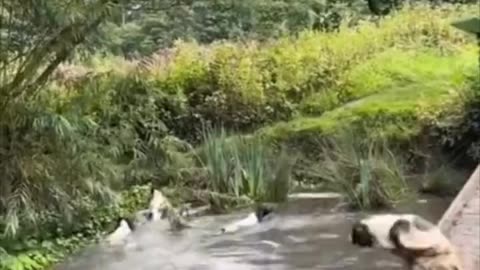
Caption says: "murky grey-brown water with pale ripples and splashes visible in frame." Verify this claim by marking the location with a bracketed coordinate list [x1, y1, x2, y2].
[56, 194, 450, 270]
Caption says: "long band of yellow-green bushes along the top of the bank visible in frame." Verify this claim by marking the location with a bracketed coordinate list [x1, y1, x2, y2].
[70, 6, 471, 142]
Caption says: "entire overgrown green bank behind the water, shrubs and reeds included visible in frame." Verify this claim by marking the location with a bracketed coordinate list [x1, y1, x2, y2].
[0, 6, 480, 269]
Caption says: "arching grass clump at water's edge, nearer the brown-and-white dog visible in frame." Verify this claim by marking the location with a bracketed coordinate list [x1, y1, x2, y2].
[307, 131, 413, 209]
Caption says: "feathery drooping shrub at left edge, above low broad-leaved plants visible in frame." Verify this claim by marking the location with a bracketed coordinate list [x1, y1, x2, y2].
[0, 98, 119, 236]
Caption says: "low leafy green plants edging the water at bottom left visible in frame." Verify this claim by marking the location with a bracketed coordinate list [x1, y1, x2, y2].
[0, 186, 150, 270]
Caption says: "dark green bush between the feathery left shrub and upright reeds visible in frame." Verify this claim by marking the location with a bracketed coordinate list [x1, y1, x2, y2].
[58, 67, 195, 186]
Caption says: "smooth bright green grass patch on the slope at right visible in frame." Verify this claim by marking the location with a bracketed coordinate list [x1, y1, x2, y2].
[260, 46, 477, 141]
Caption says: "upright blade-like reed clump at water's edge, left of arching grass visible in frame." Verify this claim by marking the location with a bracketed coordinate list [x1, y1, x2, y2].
[198, 129, 294, 202]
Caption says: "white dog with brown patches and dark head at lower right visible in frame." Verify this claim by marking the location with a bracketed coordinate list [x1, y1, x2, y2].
[350, 214, 463, 270]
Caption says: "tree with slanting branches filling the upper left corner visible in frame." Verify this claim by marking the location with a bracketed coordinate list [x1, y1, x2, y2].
[0, 0, 116, 110]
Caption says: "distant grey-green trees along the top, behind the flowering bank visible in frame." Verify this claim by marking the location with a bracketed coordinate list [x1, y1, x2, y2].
[92, 0, 363, 57]
